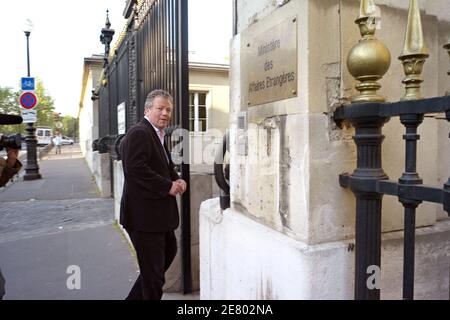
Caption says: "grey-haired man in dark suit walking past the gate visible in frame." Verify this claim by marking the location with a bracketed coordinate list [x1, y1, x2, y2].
[120, 90, 186, 300]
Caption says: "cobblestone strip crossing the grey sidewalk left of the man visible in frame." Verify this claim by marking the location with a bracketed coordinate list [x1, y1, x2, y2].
[0, 199, 114, 243]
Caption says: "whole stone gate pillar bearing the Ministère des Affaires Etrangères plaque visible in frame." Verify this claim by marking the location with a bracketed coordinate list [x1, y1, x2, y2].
[200, 0, 450, 299]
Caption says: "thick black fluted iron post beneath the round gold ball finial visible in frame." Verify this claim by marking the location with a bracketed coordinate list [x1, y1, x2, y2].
[351, 117, 388, 300]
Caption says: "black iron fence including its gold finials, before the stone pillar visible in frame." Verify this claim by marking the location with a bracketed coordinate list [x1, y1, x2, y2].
[333, 0, 450, 299]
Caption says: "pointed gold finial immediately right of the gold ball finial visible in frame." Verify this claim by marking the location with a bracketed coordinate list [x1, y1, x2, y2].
[399, 0, 430, 100]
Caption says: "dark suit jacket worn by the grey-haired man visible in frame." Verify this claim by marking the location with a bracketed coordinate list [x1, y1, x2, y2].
[120, 119, 180, 232]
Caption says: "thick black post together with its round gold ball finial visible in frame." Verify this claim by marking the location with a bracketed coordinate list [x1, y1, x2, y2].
[347, 0, 391, 300]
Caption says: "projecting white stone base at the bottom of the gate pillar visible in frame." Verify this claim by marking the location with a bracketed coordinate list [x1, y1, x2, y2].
[200, 199, 450, 300]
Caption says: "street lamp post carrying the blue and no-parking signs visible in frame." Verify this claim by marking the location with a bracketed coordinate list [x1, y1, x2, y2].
[23, 19, 42, 180]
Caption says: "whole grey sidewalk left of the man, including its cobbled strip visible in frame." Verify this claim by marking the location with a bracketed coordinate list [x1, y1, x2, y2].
[0, 145, 198, 300]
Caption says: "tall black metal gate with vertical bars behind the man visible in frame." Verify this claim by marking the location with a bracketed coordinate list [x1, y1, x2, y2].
[96, 0, 192, 293]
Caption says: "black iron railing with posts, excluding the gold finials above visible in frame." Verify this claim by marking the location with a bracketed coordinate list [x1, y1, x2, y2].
[334, 96, 450, 299]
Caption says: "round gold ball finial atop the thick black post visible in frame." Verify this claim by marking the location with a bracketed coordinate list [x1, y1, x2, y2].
[347, 0, 391, 103]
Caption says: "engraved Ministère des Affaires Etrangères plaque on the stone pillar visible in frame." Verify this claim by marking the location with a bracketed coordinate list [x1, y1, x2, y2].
[241, 17, 298, 107]
